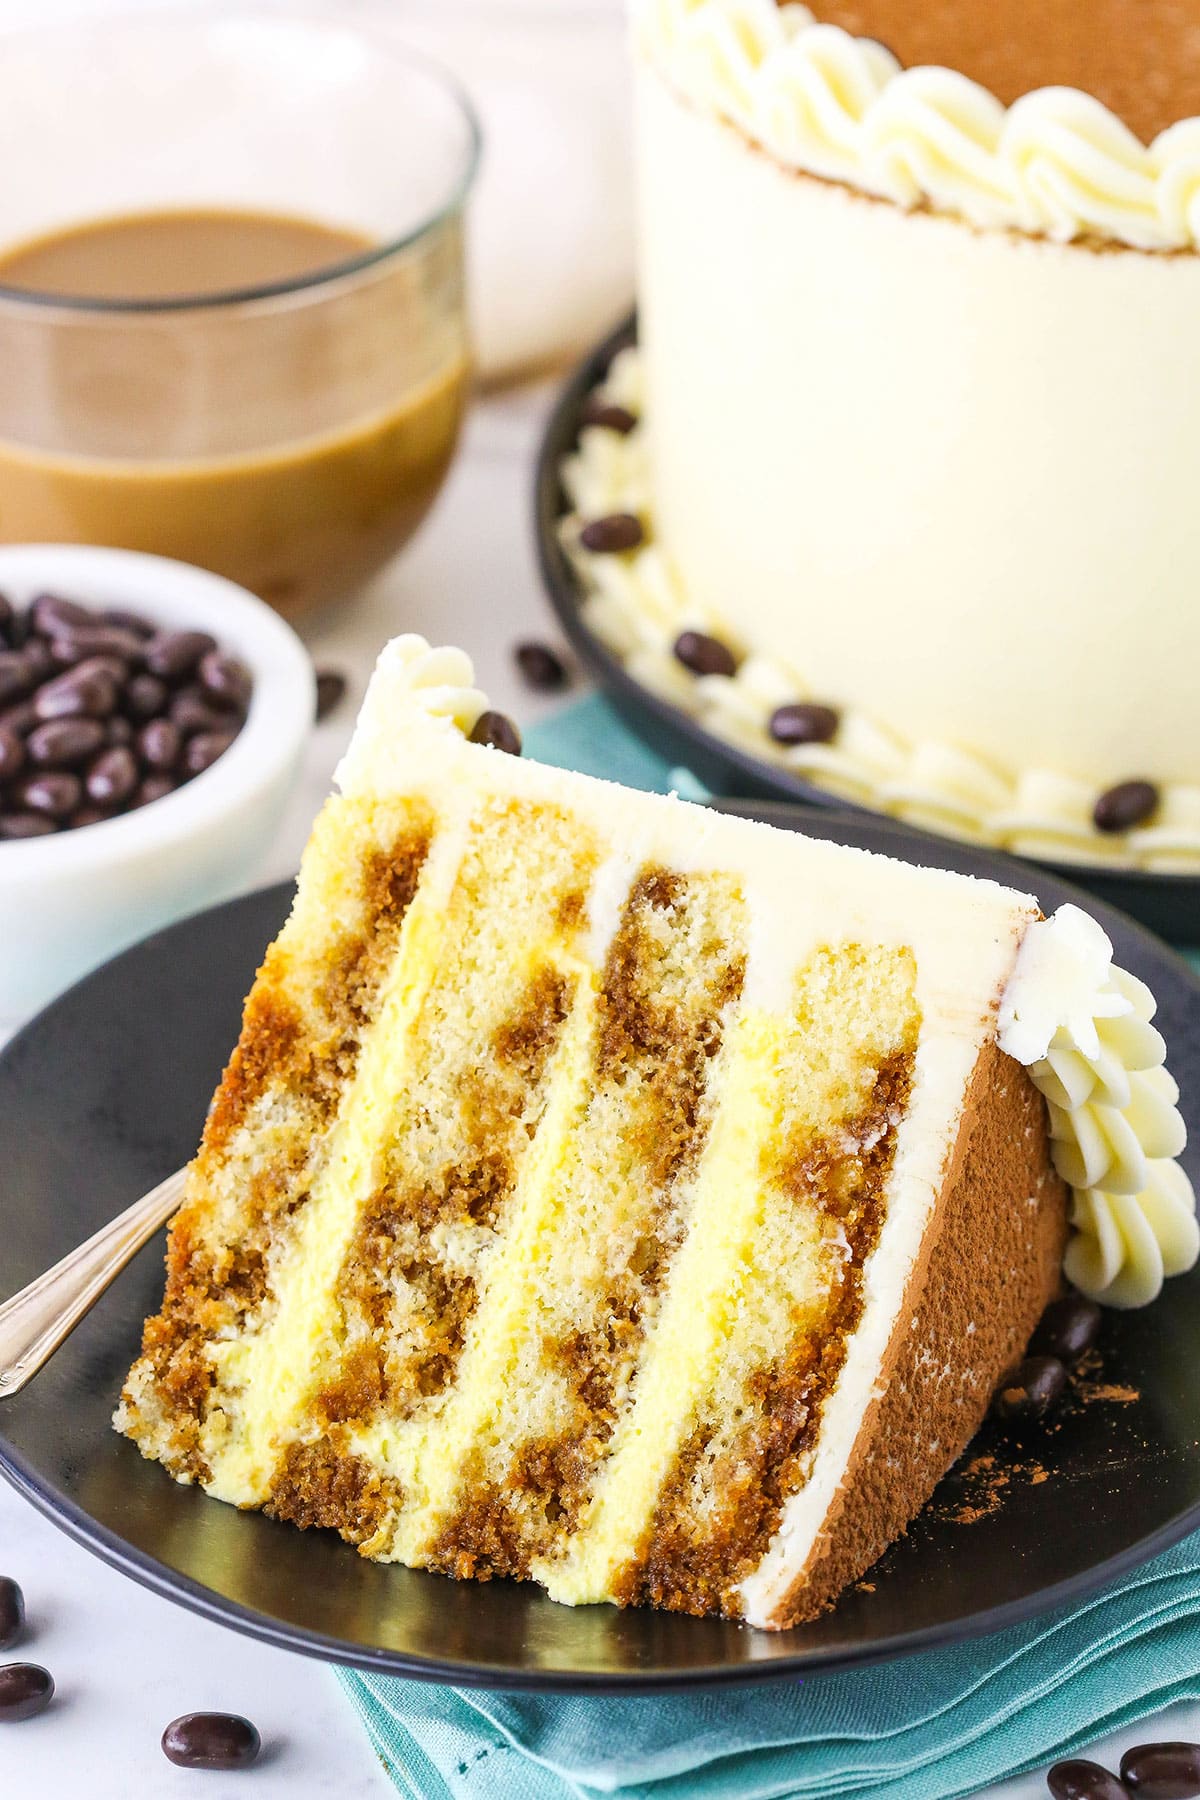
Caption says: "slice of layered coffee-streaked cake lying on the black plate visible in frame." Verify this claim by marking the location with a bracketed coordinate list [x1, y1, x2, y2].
[117, 637, 1195, 1625]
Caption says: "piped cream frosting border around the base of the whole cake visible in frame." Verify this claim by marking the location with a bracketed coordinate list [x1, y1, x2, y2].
[560, 347, 1200, 875]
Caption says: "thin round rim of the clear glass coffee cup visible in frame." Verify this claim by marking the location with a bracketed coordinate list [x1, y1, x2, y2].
[0, 4, 484, 317]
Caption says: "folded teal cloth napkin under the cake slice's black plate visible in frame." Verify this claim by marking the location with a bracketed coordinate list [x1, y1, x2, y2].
[338, 697, 1200, 1800]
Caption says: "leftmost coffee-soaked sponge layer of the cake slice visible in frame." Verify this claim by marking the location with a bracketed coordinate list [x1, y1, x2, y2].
[122, 799, 432, 1481]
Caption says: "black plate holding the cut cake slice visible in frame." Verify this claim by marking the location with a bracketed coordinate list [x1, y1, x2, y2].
[0, 824, 1200, 1690]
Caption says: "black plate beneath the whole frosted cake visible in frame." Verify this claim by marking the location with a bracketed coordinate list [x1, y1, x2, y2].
[534, 319, 1200, 943]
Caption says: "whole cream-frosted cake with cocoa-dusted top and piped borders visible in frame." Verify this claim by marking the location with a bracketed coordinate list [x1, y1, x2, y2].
[567, 0, 1200, 871]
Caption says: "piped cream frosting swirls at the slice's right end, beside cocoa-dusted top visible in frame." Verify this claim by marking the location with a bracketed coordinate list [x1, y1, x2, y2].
[997, 905, 1200, 1307]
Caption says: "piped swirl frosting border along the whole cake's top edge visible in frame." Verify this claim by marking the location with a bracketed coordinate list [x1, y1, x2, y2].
[631, 0, 1200, 250]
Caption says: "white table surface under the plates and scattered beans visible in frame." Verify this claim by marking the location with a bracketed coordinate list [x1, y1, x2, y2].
[0, 389, 1200, 1800]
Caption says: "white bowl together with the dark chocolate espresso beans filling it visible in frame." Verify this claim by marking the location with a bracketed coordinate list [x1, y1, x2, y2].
[0, 544, 315, 1026]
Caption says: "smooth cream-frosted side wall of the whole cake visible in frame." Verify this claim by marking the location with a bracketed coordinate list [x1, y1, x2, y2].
[639, 70, 1200, 799]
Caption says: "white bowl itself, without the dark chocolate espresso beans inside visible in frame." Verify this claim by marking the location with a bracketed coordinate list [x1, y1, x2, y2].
[0, 544, 315, 1026]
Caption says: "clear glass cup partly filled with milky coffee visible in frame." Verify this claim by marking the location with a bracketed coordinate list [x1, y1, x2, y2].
[0, 5, 479, 614]
